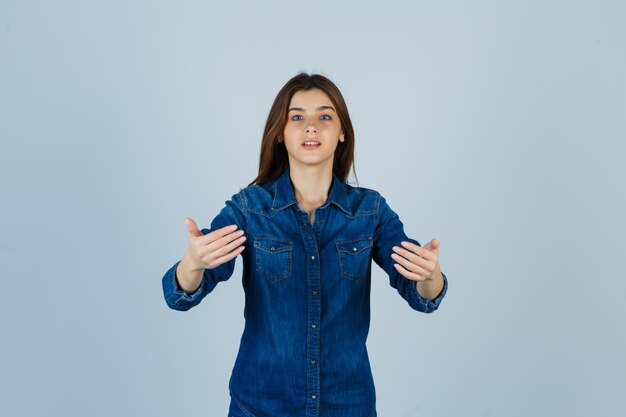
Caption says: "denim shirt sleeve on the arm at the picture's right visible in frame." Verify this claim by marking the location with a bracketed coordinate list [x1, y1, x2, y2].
[372, 195, 448, 313]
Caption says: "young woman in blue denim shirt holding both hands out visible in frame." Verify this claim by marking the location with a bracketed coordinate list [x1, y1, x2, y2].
[162, 73, 448, 417]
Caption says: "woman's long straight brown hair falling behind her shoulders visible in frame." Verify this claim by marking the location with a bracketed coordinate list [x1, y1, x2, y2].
[248, 72, 358, 185]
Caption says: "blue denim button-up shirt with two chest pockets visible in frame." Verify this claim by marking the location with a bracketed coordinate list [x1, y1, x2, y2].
[162, 169, 448, 417]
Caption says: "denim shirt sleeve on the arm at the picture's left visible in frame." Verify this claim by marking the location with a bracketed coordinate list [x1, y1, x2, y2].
[161, 190, 248, 311]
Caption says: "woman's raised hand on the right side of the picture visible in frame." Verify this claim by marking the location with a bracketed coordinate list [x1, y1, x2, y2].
[391, 239, 440, 281]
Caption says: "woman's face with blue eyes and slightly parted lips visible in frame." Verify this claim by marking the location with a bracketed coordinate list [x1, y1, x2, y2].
[283, 88, 344, 170]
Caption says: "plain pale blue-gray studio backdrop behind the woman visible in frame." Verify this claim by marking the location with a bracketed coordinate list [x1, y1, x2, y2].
[0, 0, 626, 417]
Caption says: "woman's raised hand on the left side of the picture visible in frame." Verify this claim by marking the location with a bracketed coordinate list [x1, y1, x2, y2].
[185, 217, 246, 271]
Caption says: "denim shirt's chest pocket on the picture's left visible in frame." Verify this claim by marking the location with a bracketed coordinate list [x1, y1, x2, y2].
[254, 236, 293, 282]
